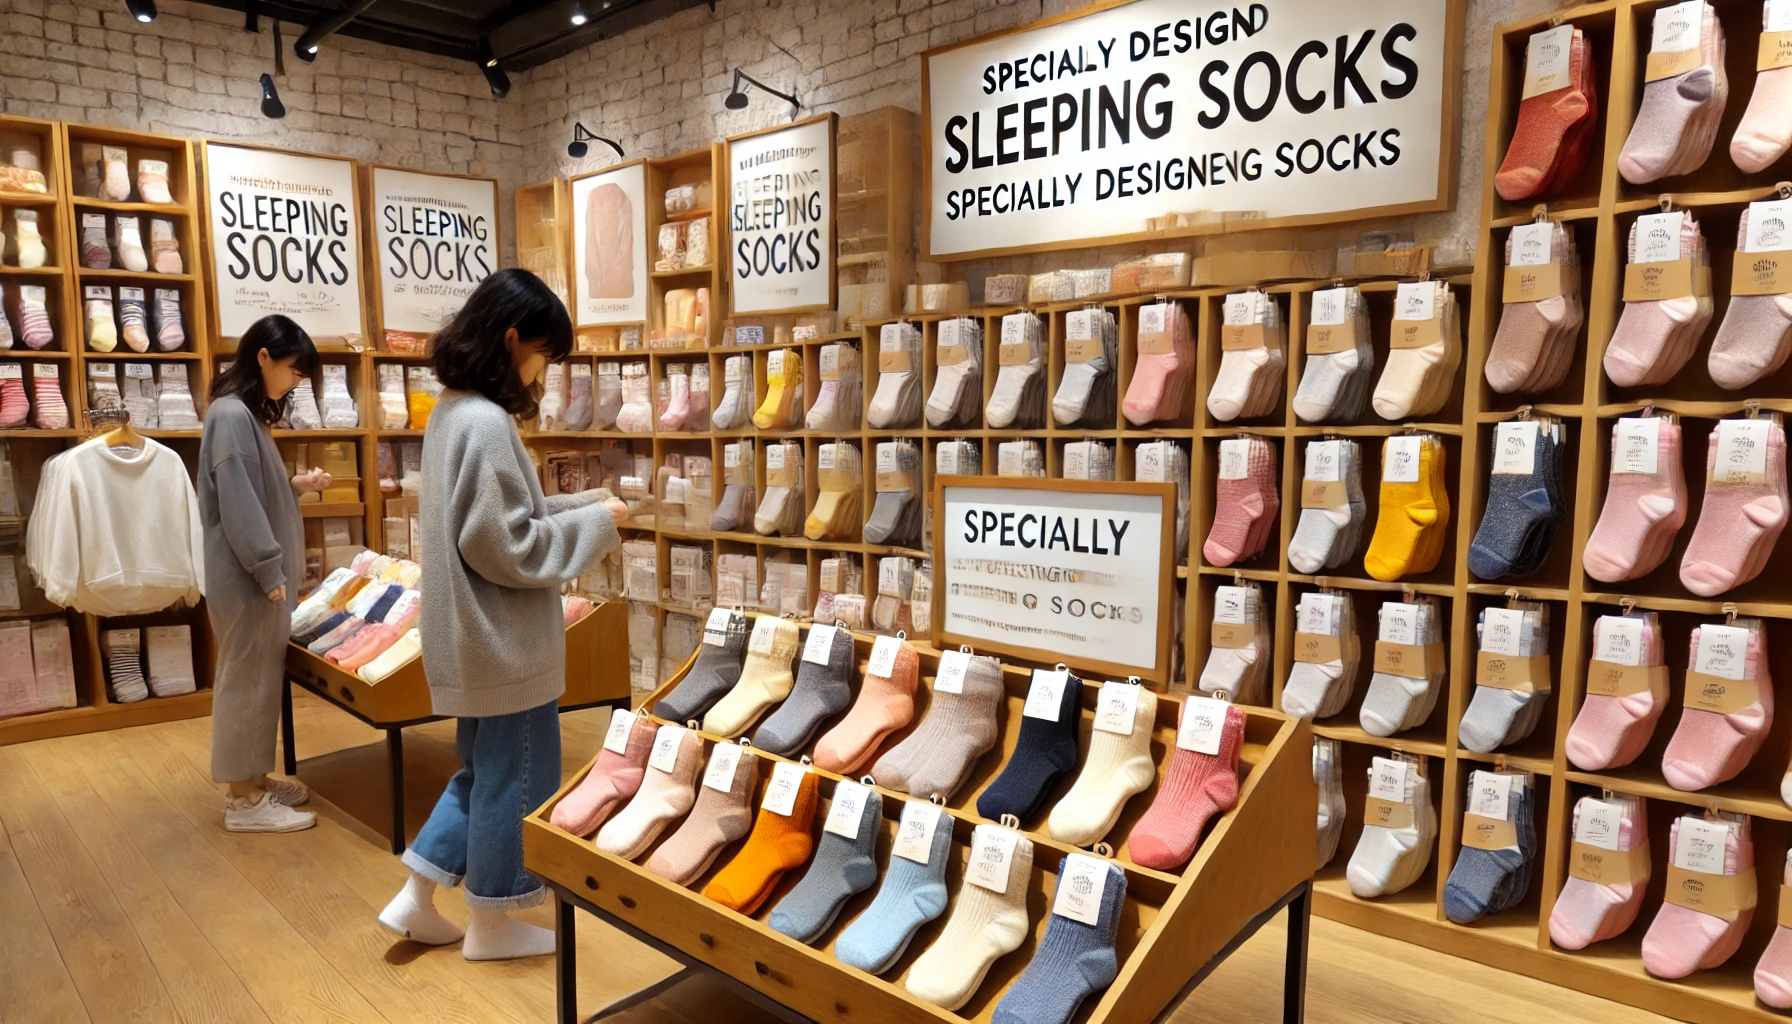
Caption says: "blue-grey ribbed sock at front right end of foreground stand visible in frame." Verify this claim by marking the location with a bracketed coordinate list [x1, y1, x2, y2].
[989, 863, 1125, 1024]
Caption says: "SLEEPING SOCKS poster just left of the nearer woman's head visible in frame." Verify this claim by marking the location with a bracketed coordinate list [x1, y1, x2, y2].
[367, 165, 500, 351]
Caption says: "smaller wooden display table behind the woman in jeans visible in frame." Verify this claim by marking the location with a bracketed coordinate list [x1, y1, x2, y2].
[280, 601, 629, 854]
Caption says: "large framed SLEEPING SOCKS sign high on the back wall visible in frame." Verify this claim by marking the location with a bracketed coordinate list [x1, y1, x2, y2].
[921, 0, 1462, 258]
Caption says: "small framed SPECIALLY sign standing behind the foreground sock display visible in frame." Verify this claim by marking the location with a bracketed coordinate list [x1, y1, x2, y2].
[934, 477, 1176, 680]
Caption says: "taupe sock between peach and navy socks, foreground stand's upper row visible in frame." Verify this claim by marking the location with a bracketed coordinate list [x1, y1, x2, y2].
[871, 653, 1007, 800]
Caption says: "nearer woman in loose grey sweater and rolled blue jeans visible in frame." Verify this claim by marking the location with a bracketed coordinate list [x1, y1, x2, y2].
[380, 269, 627, 959]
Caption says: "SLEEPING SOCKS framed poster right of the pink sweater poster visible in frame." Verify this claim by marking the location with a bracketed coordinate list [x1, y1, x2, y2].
[728, 113, 839, 314]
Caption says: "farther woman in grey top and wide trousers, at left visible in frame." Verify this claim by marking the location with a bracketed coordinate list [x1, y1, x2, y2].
[199, 316, 330, 832]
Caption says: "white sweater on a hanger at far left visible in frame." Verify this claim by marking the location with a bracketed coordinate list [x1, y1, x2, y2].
[25, 438, 206, 615]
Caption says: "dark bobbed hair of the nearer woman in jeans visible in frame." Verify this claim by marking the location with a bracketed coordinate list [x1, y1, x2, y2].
[432, 267, 572, 418]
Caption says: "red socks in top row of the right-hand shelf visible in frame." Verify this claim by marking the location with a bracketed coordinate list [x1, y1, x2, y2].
[1493, 29, 1598, 203]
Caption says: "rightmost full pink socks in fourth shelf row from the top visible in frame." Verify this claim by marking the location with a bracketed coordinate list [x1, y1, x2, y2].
[1661, 619, 1774, 793]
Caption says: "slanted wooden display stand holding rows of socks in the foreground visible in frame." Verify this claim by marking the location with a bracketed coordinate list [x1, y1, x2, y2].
[523, 635, 1317, 1024]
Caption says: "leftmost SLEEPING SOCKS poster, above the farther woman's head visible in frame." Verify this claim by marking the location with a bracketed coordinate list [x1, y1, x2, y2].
[204, 142, 367, 348]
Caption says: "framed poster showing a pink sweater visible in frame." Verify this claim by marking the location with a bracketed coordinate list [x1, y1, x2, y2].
[572, 160, 647, 326]
